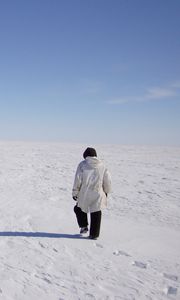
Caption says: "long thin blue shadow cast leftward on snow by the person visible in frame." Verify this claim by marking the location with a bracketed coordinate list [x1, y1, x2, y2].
[0, 231, 85, 239]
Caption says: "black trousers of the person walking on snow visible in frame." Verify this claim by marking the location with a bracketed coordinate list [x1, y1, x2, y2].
[74, 205, 102, 237]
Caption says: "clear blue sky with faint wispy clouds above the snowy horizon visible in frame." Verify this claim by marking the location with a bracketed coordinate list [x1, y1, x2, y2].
[0, 0, 180, 145]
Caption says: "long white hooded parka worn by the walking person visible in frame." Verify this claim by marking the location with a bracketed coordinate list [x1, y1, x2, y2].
[72, 156, 111, 213]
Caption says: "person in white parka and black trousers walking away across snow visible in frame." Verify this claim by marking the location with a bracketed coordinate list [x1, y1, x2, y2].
[72, 147, 111, 239]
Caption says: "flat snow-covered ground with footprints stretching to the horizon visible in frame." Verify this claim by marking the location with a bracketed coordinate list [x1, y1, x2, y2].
[0, 142, 180, 300]
